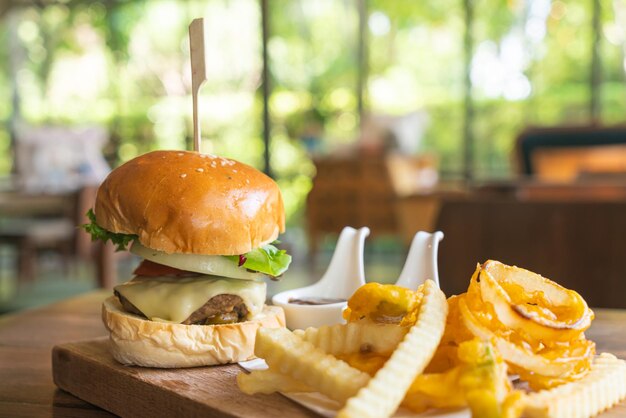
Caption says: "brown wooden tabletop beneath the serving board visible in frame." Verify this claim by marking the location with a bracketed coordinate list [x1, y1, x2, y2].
[0, 291, 626, 417]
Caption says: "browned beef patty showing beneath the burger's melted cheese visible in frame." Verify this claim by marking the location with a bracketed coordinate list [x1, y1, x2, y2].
[114, 291, 248, 325]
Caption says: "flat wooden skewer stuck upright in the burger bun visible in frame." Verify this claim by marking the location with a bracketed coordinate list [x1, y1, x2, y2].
[189, 18, 207, 152]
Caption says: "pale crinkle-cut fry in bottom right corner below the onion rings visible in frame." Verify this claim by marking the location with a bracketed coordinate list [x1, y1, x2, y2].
[524, 353, 626, 418]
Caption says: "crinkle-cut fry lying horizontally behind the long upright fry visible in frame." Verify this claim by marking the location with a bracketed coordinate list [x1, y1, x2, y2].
[294, 322, 409, 356]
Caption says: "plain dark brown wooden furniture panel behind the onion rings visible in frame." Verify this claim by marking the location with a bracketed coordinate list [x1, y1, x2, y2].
[436, 196, 626, 309]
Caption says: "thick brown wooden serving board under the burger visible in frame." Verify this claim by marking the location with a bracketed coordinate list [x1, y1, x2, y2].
[52, 338, 318, 417]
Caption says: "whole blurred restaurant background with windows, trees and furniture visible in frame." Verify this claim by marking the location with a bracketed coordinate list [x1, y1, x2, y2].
[0, 0, 626, 312]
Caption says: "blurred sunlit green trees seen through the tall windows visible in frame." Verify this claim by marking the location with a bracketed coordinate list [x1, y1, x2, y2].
[0, 0, 626, 222]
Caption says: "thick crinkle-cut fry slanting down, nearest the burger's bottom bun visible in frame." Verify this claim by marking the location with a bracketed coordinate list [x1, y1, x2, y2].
[254, 328, 370, 402]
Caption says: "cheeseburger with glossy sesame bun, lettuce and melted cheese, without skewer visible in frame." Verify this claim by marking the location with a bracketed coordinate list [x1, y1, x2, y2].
[84, 151, 291, 368]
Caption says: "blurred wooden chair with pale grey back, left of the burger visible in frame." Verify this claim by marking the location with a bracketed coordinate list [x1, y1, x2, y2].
[0, 125, 115, 287]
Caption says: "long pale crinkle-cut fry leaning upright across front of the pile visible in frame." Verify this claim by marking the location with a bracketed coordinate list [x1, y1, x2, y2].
[337, 280, 448, 418]
